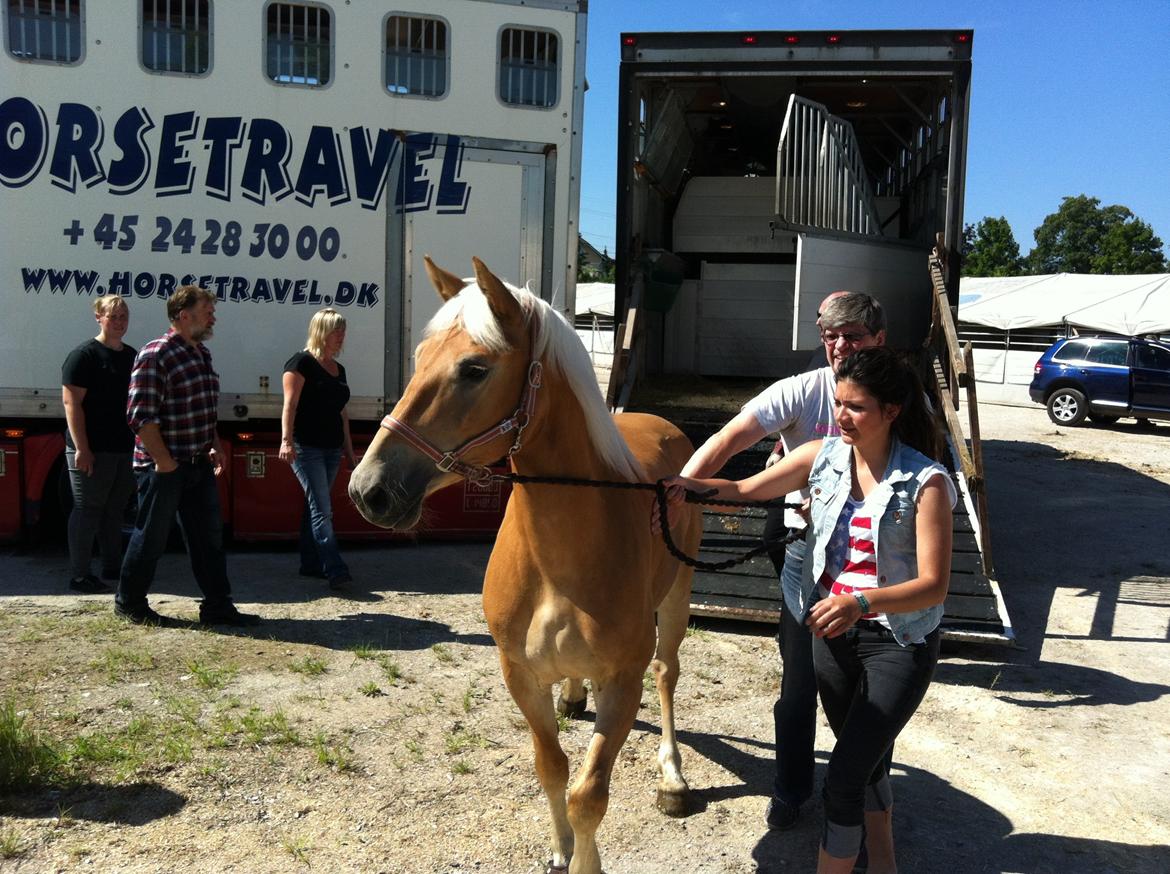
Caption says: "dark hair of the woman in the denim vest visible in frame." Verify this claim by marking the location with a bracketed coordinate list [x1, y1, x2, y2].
[837, 346, 944, 461]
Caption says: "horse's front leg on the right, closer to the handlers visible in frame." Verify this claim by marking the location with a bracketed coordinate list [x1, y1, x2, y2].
[569, 668, 644, 874]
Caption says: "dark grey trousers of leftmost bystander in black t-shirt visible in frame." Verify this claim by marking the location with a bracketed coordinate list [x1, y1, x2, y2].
[66, 447, 135, 579]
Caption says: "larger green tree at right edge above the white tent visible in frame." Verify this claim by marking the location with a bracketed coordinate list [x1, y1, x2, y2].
[1028, 194, 1165, 274]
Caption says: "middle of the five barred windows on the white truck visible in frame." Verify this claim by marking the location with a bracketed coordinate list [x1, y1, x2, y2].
[264, 4, 333, 88]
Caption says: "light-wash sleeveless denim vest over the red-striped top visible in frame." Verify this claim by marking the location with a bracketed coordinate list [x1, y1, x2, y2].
[800, 436, 947, 646]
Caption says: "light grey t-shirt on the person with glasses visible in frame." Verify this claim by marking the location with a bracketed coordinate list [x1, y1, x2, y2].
[743, 366, 841, 528]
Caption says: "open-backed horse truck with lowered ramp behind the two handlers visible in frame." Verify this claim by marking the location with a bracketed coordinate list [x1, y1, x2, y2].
[611, 29, 1010, 638]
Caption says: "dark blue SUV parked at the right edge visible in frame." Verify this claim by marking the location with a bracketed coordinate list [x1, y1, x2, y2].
[1028, 337, 1170, 425]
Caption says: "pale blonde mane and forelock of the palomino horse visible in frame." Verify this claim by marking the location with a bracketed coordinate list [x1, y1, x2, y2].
[424, 278, 646, 482]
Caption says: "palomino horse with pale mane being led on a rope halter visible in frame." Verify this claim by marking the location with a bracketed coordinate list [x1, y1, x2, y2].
[350, 257, 700, 874]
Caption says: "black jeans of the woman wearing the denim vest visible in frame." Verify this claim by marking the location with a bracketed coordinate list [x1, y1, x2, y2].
[812, 621, 938, 842]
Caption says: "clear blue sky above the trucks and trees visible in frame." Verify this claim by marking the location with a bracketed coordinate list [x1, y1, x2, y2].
[580, 0, 1170, 254]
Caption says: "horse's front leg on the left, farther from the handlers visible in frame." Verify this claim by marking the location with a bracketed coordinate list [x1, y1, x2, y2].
[500, 653, 573, 868]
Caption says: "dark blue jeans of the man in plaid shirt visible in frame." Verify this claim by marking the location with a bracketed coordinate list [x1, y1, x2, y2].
[113, 457, 232, 612]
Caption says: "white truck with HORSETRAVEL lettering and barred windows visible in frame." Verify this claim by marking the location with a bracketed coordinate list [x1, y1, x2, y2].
[0, 0, 587, 539]
